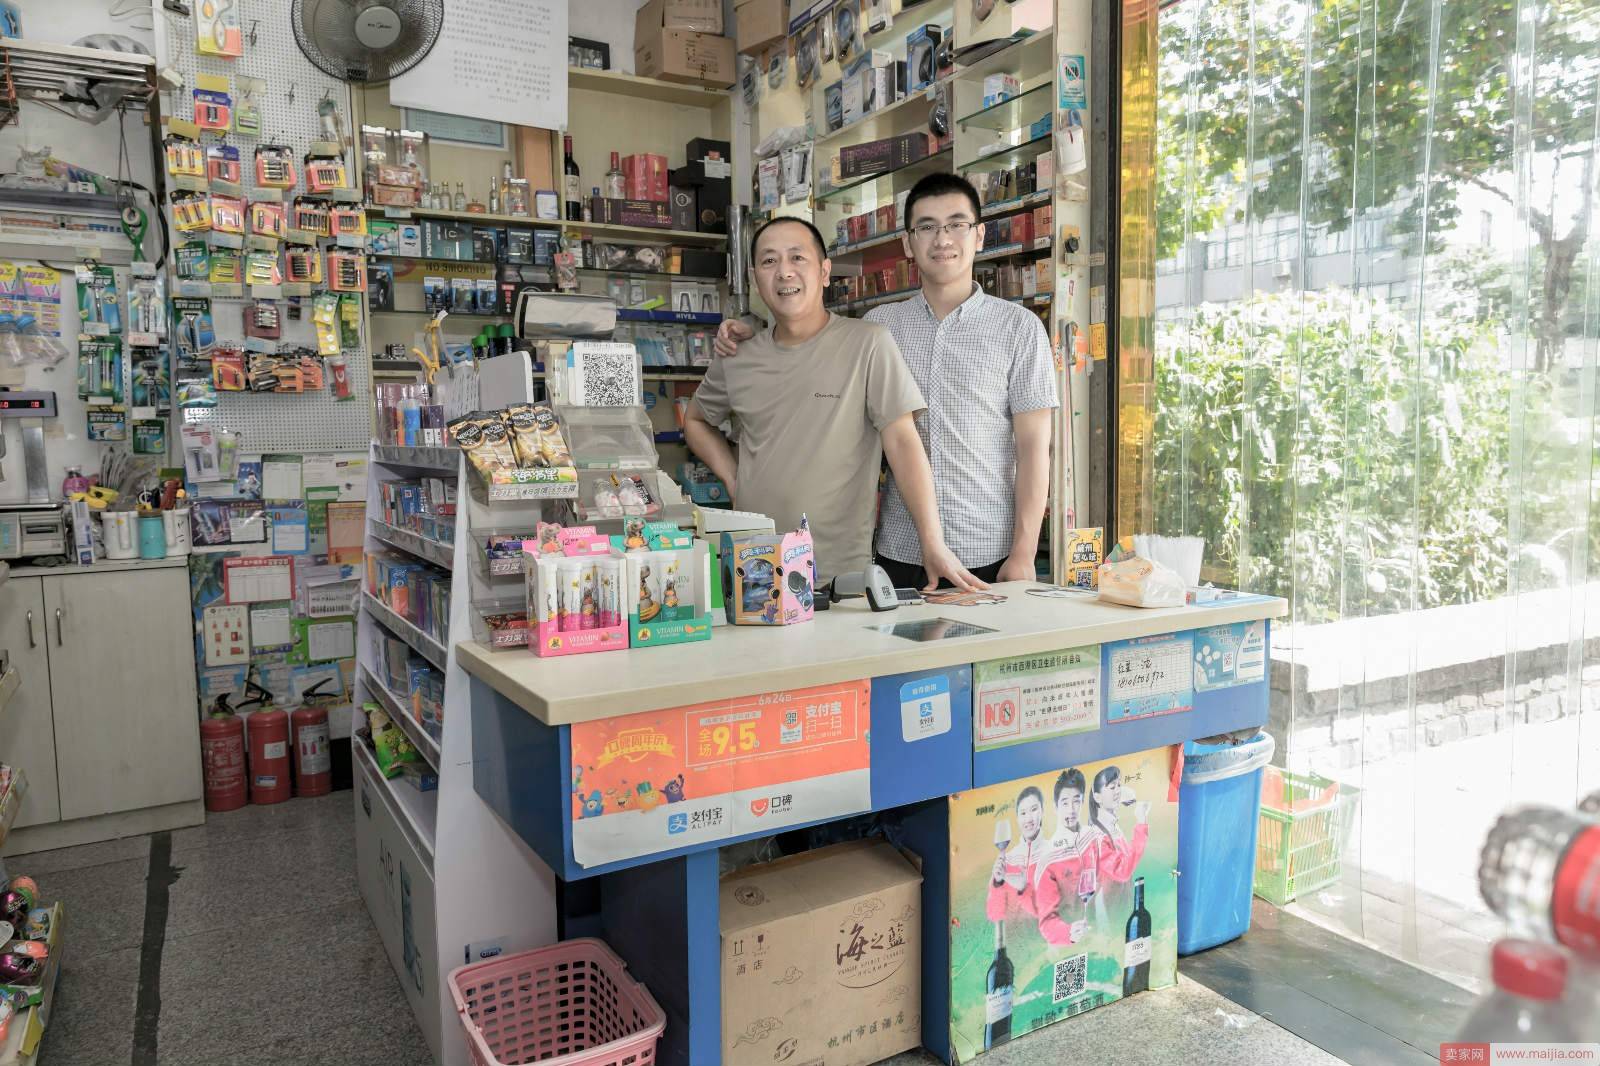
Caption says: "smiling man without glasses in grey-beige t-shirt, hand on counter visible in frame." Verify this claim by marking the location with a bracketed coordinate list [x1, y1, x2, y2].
[683, 218, 974, 589]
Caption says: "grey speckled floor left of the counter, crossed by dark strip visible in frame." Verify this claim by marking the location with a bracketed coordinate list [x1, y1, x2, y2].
[30, 792, 432, 1066]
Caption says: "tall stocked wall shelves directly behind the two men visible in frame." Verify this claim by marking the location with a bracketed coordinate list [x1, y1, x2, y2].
[736, 0, 1106, 575]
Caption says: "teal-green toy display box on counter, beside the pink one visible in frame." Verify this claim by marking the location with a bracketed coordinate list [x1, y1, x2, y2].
[611, 519, 712, 648]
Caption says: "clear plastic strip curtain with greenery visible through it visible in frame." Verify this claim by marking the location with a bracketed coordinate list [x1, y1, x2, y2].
[1118, 0, 1600, 983]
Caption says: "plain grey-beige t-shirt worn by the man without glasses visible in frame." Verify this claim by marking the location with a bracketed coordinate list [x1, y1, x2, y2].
[694, 315, 926, 578]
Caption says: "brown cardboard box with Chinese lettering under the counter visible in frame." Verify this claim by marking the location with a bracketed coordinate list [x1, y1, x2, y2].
[720, 840, 922, 1066]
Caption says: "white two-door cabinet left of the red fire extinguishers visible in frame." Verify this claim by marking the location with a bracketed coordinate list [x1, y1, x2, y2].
[0, 559, 205, 853]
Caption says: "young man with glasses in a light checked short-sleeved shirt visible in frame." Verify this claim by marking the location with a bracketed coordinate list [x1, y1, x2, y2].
[715, 174, 1059, 587]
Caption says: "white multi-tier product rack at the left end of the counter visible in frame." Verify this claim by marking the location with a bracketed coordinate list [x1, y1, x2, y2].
[350, 367, 555, 1066]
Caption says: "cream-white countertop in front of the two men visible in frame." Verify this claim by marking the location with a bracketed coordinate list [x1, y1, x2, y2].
[456, 581, 1288, 725]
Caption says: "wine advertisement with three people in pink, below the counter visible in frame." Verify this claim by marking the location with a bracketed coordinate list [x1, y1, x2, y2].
[950, 747, 1181, 1063]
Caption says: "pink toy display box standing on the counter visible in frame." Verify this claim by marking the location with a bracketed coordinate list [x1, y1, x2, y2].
[523, 525, 627, 656]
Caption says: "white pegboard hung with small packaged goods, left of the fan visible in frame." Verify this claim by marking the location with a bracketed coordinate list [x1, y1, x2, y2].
[154, 0, 371, 453]
